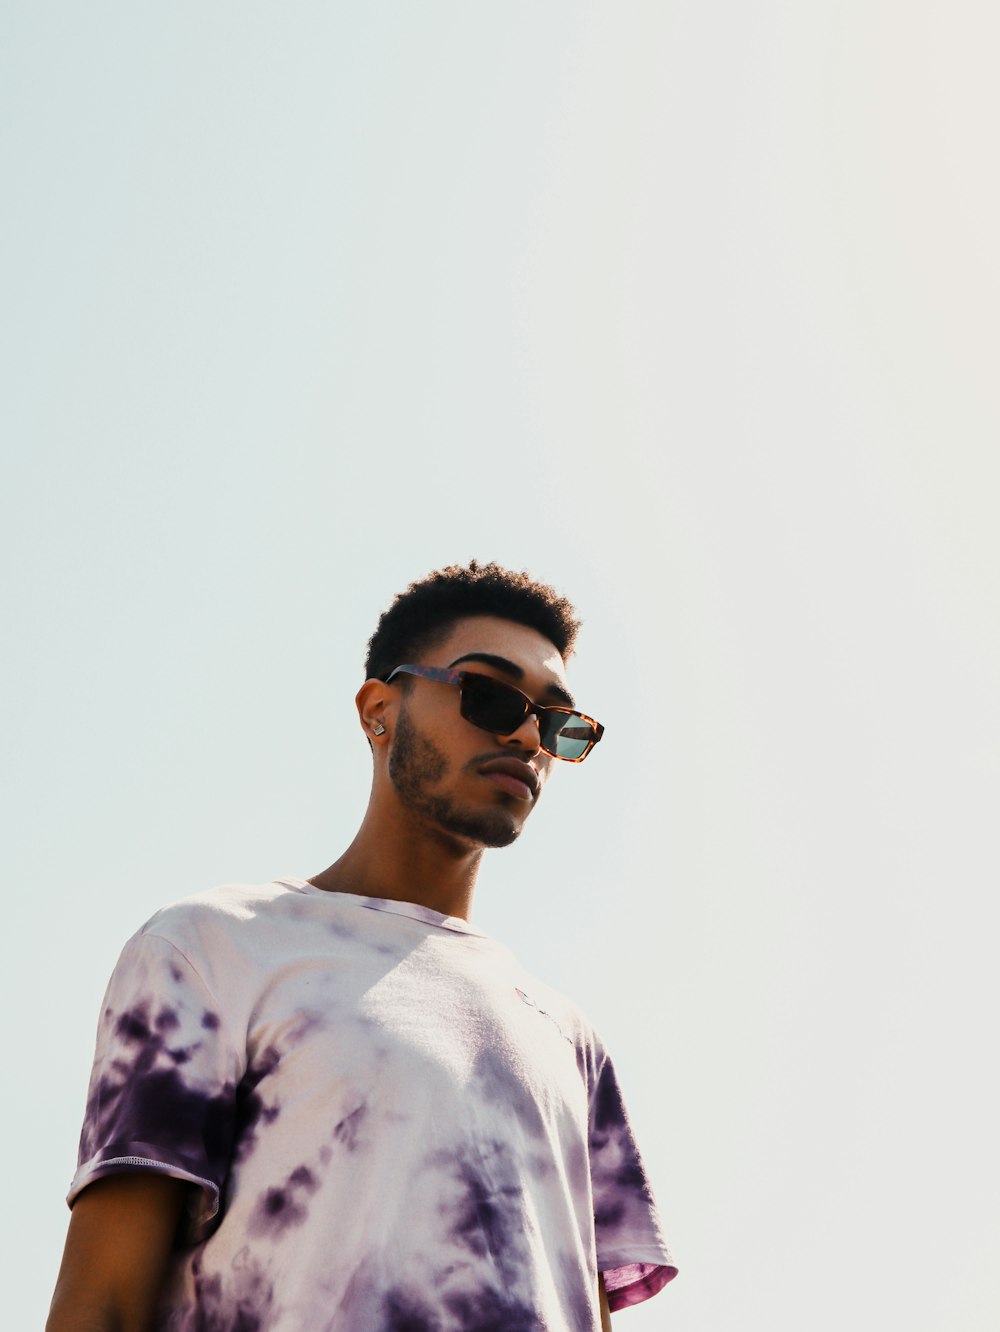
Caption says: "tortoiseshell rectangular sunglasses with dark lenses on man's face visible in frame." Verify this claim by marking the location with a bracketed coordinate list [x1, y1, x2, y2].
[386, 666, 605, 763]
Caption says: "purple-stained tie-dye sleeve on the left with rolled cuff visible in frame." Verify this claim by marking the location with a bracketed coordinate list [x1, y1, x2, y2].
[67, 932, 240, 1239]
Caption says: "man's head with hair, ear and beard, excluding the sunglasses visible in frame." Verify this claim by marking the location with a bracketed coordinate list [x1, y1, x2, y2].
[357, 562, 579, 847]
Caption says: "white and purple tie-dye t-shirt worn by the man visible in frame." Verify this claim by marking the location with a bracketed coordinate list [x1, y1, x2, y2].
[69, 879, 675, 1332]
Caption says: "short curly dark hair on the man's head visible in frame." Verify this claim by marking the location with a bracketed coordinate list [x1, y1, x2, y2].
[365, 559, 581, 679]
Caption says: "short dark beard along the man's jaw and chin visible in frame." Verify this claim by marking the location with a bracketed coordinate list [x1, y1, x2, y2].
[389, 705, 521, 847]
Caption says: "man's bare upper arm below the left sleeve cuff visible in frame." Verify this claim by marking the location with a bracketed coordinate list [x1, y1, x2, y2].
[45, 1171, 190, 1332]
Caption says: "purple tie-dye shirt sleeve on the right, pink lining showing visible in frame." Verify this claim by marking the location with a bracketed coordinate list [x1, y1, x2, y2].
[590, 1055, 676, 1313]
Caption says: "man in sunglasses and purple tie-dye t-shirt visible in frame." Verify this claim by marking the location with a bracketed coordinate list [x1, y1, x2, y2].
[48, 562, 676, 1332]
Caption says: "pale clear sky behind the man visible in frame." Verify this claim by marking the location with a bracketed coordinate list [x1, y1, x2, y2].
[0, 0, 1000, 1332]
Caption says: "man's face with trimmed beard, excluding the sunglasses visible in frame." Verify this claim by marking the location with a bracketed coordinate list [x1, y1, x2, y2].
[389, 615, 570, 846]
